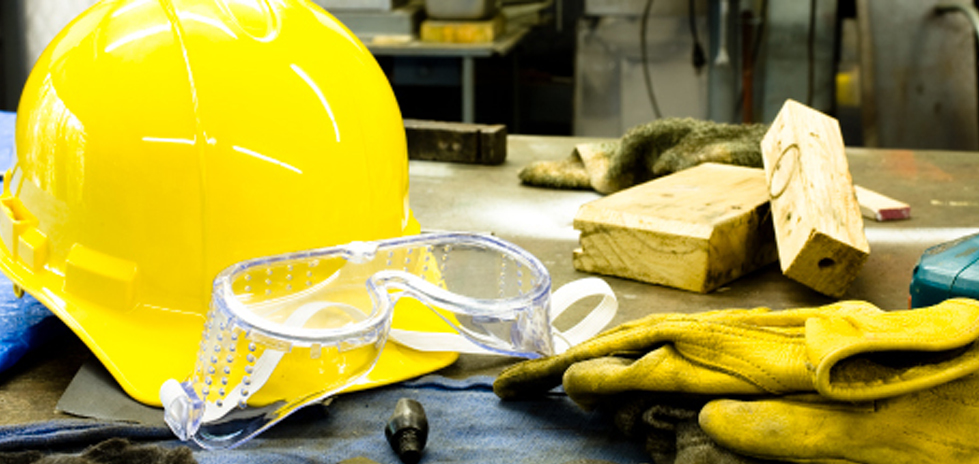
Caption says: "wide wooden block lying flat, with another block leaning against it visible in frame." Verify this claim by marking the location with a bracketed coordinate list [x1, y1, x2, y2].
[574, 163, 776, 293]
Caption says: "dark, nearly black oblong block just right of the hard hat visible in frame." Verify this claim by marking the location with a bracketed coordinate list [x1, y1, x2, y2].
[405, 119, 506, 164]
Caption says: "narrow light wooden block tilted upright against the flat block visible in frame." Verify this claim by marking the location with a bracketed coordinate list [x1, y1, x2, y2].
[761, 100, 870, 297]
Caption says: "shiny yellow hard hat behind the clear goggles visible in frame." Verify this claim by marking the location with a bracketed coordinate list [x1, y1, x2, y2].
[0, 0, 457, 405]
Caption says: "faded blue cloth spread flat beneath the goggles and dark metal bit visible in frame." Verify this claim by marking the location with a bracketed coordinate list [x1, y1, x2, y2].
[0, 375, 650, 464]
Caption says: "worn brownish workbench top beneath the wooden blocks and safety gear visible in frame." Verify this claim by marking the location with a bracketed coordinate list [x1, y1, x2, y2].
[0, 136, 979, 424]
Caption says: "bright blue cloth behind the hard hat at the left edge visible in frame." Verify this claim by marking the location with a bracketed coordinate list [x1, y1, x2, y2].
[0, 111, 67, 373]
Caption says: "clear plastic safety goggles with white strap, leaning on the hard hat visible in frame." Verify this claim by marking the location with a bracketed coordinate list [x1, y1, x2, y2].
[160, 233, 617, 448]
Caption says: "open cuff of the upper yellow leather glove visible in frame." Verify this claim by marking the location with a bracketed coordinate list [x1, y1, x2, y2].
[806, 299, 979, 401]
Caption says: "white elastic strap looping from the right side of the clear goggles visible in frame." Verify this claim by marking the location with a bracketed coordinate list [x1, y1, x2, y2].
[390, 277, 619, 354]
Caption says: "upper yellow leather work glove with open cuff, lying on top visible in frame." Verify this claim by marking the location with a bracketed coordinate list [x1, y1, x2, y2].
[493, 299, 979, 408]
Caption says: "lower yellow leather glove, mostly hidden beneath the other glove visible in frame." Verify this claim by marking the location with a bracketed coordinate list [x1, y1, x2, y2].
[699, 374, 979, 464]
